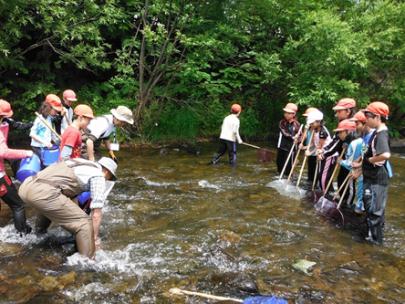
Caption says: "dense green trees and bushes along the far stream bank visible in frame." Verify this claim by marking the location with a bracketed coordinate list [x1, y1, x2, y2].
[0, 0, 405, 140]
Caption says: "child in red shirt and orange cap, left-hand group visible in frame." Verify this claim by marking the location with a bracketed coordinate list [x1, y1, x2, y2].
[59, 105, 94, 160]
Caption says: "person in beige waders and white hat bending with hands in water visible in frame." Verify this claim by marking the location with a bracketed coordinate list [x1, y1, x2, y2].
[18, 157, 117, 258]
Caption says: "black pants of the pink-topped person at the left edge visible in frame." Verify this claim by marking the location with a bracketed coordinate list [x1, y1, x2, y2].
[0, 175, 31, 233]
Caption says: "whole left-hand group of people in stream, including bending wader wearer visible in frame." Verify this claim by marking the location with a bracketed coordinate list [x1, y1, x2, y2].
[0, 90, 134, 257]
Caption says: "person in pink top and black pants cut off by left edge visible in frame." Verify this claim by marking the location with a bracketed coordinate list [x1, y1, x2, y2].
[0, 99, 33, 234]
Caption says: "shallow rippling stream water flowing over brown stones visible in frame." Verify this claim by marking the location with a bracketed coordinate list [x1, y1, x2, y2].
[0, 145, 405, 303]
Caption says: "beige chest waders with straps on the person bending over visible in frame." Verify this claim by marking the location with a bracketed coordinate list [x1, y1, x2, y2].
[19, 162, 100, 258]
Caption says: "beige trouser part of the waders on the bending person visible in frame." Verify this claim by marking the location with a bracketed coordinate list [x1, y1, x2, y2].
[18, 177, 95, 258]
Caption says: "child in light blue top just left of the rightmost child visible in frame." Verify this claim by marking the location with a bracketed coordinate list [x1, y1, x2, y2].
[334, 119, 363, 207]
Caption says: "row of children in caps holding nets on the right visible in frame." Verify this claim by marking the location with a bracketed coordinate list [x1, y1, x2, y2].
[277, 98, 392, 244]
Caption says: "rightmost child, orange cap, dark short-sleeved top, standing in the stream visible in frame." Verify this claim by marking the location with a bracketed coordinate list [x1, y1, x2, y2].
[356, 101, 392, 244]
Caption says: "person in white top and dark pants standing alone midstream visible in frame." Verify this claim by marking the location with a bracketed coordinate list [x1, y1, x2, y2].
[211, 103, 243, 165]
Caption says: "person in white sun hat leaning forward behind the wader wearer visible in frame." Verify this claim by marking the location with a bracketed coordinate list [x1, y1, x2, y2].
[82, 106, 134, 161]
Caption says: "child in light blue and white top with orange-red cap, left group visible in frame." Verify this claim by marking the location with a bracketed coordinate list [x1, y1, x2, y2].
[30, 94, 62, 159]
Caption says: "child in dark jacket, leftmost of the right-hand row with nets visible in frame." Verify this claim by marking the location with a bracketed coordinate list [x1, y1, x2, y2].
[277, 103, 300, 175]
